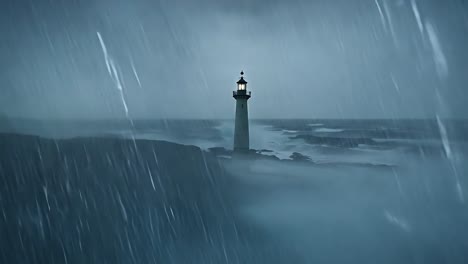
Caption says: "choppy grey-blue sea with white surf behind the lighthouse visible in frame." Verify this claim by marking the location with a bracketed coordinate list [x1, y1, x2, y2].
[9, 119, 468, 166]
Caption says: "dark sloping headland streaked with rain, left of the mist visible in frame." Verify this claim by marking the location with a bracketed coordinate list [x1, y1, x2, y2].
[0, 134, 300, 264]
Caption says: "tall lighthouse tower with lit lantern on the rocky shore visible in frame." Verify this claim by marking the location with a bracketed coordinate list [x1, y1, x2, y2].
[232, 71, 251, 152]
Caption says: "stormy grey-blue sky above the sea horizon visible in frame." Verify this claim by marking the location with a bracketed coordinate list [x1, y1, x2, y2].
[0, 0, 468, 119]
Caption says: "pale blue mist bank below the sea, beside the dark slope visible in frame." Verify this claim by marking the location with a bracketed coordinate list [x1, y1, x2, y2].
[228, 140, 468, 263]
